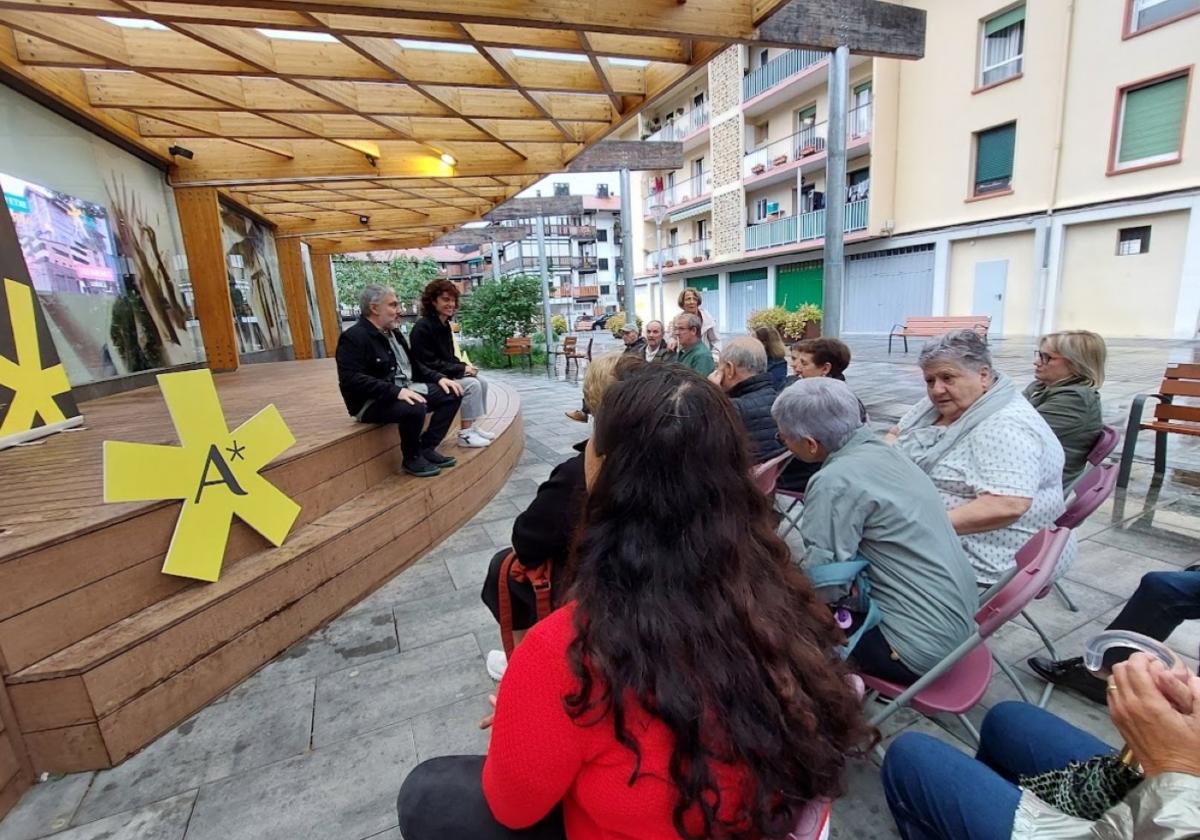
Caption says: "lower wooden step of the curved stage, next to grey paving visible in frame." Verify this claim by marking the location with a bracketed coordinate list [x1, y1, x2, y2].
[0, 389, 523, 772]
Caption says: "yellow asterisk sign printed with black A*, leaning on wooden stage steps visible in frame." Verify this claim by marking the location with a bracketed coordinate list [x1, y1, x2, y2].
[104, 370, 300, 581]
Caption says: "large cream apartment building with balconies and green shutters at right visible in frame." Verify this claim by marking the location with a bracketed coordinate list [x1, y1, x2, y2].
[625, 0, 1200, 338]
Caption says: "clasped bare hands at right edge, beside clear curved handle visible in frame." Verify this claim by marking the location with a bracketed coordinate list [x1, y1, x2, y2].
[1108, 653, 1200, 778]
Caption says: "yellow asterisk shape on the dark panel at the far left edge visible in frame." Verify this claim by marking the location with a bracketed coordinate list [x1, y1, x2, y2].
[0, 277, 71, 438]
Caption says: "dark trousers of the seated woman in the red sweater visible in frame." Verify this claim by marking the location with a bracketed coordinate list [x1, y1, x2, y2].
[396, 756, 566, 840]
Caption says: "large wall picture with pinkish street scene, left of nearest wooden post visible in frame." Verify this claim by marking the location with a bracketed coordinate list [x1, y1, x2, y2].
[0, 173, 197, 384]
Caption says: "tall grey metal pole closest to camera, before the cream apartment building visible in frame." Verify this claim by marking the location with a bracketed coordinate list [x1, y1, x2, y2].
[821, 47, 850, 338]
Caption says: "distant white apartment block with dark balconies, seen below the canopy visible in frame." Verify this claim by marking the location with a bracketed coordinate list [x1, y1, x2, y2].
[500, 180, 622, 323]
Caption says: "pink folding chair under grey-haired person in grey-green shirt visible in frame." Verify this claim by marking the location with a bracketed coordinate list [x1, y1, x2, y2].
[863, 526, 1070, 743]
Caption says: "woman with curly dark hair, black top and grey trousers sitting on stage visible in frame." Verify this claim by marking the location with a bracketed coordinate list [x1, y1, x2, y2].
[409, 280, 496, 448]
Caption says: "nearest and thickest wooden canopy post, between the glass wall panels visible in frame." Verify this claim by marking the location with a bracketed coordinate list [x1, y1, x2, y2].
[175, 187, 239, 371]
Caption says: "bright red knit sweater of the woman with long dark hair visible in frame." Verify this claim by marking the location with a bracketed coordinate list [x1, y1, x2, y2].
[484, 604, 742, 840]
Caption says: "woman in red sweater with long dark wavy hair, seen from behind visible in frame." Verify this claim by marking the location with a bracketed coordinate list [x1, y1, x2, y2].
[397, 365, 872, 840]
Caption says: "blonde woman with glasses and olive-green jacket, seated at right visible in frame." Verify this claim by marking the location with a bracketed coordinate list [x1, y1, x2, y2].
[1025, 330, 1106, 487]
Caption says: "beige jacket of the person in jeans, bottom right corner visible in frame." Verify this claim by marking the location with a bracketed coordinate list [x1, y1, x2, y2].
[1013, 773, 1200, 840]
